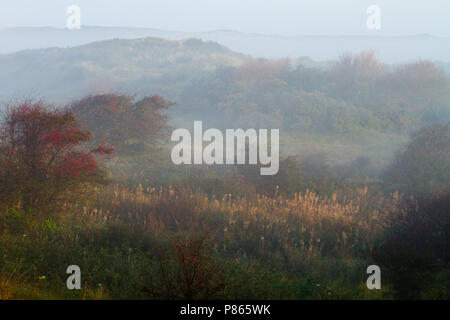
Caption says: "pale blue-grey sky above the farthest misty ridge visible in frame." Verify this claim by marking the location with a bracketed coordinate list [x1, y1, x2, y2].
[0, 0, 450, 37]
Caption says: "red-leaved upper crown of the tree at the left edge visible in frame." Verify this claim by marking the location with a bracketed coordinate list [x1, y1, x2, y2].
[0, 102, 113, 180]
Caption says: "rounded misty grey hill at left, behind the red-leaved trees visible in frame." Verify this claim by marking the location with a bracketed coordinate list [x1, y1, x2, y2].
[0, 38, 248, 101]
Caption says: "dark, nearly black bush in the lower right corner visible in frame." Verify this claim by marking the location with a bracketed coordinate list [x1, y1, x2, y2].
[374, 194, 450, 299]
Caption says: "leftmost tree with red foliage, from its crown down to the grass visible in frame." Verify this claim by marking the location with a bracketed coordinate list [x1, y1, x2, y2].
[0, 101, 113, 213]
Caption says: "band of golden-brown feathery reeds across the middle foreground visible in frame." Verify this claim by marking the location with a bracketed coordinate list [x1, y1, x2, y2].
[77, 186, 399, 267]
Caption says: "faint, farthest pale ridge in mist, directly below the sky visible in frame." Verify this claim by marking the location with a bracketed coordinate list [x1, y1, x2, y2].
[0, 27, 450, 63]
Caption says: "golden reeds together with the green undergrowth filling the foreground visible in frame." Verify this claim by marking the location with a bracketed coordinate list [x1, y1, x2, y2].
[0, 185, 398, 299]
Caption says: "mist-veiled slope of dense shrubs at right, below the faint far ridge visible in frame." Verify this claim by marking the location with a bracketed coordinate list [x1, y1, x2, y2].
[174, 52, 450, 136]
